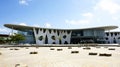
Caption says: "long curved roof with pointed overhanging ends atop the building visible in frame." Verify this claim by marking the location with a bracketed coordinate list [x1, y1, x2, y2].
[4, 24, 118, 31]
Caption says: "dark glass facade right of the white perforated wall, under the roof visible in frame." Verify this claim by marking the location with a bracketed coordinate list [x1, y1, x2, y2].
[71, 29, 105, 44]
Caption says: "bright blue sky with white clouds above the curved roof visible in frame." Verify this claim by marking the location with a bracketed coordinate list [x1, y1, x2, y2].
[0, 0, 120, 34]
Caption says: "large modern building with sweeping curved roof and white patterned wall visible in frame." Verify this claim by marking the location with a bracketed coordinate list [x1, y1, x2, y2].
[4, 24, 118, 45]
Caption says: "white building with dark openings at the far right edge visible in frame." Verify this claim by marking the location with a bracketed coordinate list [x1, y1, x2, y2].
[105, 32, 120, 44]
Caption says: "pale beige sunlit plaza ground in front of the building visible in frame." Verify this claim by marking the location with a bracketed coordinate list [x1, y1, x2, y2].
[0, 46, 120, 67]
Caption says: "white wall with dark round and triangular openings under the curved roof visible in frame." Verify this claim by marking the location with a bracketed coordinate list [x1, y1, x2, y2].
[33, 28, 72, 45]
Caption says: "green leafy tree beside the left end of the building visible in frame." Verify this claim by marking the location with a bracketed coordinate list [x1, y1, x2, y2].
[10, 33, 25, 43]
